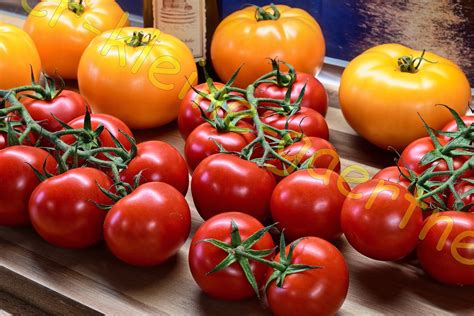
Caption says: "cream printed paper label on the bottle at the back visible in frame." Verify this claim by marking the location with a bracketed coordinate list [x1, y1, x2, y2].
[153, 0, 206, 60]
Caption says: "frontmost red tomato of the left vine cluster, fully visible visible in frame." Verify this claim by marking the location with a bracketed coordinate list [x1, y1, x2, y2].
[104, 182, 191, 266]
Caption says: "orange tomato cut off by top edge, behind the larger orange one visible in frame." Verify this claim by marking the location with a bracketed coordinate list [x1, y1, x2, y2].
[23, 0, 129, 79]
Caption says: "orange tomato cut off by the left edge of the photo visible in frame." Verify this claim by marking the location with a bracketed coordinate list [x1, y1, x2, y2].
[0, 22, 41, 90]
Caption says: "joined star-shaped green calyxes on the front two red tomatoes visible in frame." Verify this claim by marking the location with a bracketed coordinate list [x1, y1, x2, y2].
[200, 220, 318, 298]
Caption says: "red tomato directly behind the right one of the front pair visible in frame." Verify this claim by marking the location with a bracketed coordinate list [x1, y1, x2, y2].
[270, 169, 351, 240]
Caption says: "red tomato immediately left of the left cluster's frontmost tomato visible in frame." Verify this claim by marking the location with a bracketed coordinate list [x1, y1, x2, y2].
[29, 168, 112, 248]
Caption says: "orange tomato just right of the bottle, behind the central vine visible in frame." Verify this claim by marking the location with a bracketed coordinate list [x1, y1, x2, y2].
[211, 5, 326, 88]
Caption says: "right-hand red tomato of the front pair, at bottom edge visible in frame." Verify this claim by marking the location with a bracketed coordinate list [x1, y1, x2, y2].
[267, 237, 349, 316]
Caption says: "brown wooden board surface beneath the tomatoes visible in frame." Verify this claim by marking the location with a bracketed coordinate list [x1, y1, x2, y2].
[0, 12, 474, 316]
